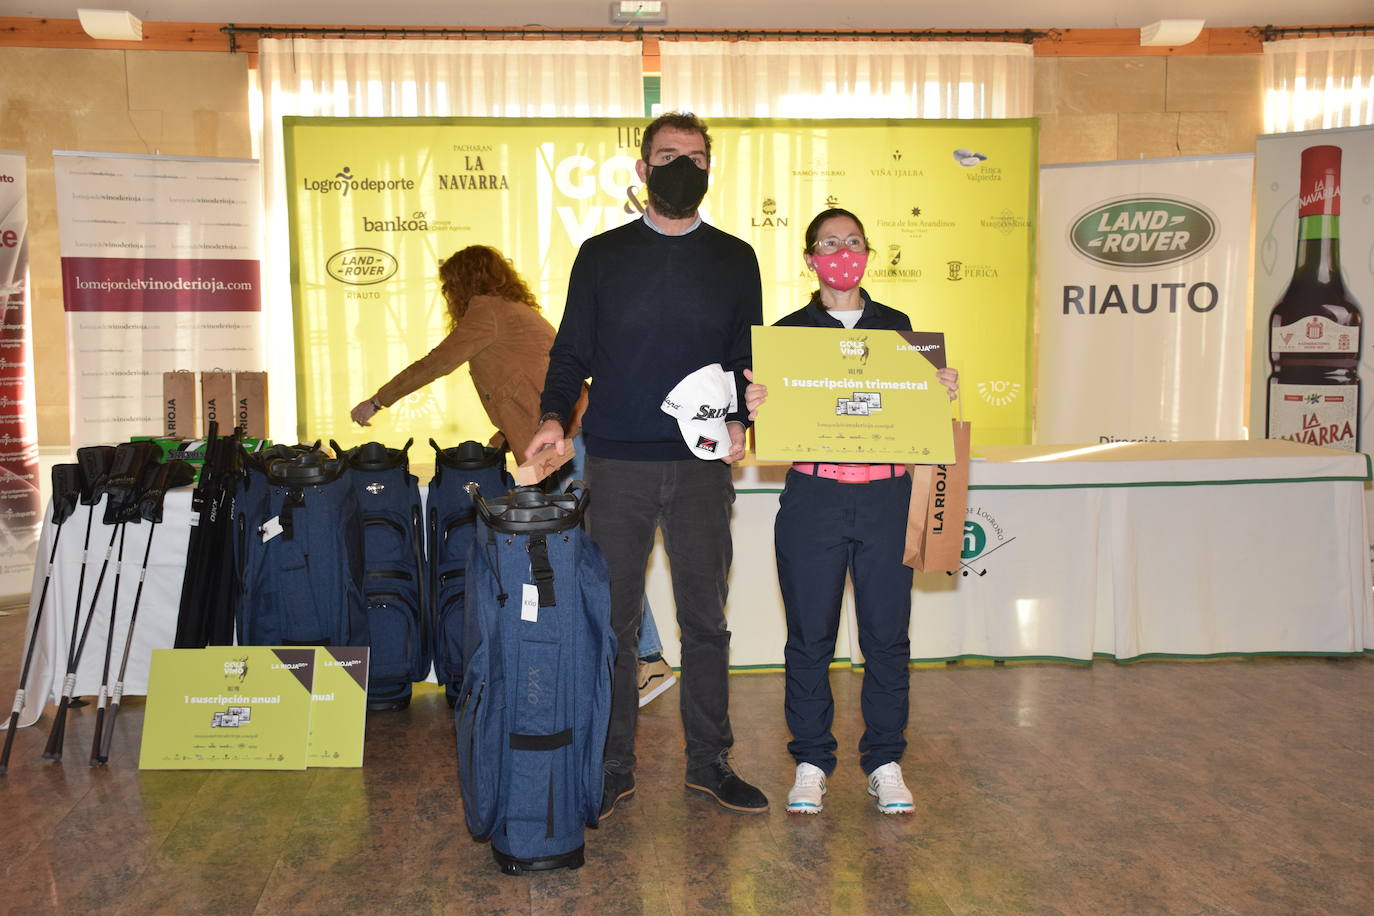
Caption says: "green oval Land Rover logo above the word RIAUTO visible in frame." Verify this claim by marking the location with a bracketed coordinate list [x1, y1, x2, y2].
[1069, 196, 1216, 268]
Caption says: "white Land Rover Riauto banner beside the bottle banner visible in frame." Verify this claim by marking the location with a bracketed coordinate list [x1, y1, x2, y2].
[1036, 155, 1253, 444]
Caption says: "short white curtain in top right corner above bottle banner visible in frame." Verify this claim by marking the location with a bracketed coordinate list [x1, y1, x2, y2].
[1263, 36, 1374, 133]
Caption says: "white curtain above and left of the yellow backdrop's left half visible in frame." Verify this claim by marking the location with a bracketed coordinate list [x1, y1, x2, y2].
[254, 38, 644, 441]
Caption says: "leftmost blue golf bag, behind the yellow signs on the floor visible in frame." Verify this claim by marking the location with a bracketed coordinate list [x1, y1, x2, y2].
[234, 445, 370, 645]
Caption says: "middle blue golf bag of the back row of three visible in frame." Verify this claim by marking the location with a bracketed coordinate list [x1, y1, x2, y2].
[330, 439, 430, 710]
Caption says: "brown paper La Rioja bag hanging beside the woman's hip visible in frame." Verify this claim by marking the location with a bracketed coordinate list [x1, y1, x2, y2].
[901, 420, 970, 573]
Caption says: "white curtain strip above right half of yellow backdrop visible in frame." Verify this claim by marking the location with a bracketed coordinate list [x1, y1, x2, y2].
[658, 40, 1035, 118]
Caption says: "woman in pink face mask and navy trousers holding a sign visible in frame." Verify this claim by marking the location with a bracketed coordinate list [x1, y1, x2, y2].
[745, 207, 959, 814]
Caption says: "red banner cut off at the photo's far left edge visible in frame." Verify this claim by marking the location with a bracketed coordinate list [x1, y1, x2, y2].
[0, 150, 43, 597]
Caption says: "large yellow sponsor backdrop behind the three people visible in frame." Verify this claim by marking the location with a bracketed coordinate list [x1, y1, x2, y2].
[281, 118, 1036, 445]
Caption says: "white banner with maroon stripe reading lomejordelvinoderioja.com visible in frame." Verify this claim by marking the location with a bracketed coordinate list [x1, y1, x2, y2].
[54, 151, 265, 448]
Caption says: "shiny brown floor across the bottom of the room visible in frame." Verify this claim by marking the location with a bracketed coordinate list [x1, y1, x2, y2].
[0, 604, 1374, 916]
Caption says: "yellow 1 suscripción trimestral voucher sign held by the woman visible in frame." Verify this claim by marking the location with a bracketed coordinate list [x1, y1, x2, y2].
[753, 327, 955, 464]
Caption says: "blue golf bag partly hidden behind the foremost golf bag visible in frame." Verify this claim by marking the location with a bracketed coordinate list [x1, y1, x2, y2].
[426, 439, 514, 706]
